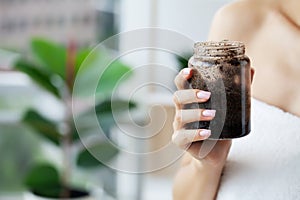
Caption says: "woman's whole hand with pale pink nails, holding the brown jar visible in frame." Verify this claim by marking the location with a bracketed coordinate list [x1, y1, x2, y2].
[172, 68, 231, 170]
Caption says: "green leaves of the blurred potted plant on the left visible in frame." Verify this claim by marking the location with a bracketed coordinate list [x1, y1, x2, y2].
[9, 38, 135, 198]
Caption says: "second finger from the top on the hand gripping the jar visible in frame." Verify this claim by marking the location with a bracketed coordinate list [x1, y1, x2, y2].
[173, 89, 211, 109]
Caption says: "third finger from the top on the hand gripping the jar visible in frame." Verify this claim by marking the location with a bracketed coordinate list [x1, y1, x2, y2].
[173, 109, 216, 130]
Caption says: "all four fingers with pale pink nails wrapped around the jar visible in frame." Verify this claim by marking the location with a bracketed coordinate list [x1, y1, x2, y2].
[172, 68, 216, 158]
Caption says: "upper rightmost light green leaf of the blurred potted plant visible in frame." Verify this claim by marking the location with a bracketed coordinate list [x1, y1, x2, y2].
[96, 61, 132, 94]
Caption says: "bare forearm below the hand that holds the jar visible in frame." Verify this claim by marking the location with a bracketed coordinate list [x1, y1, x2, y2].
[173, 158, 222, 200]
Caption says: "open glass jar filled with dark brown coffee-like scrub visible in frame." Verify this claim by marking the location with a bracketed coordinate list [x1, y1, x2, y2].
[186, 40, 251, 139]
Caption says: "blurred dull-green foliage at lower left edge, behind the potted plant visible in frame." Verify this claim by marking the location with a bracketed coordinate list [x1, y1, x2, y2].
[0, 122, 40, 191]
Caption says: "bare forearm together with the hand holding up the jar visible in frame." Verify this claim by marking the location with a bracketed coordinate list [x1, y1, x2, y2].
[173, 70, 231, 200]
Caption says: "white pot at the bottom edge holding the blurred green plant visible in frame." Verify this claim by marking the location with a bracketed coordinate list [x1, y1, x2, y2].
[24, 190, 96, 200]
